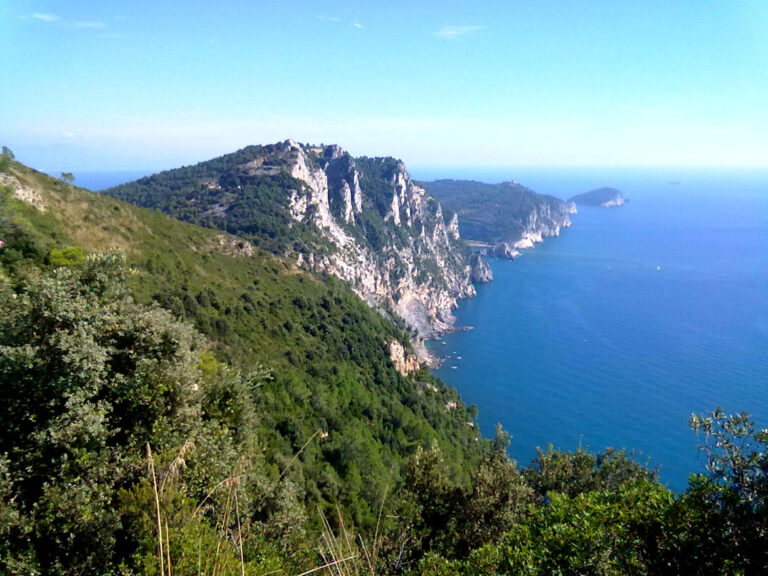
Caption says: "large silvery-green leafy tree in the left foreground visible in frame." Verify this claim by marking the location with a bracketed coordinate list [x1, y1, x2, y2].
[0, 254, 206, 574]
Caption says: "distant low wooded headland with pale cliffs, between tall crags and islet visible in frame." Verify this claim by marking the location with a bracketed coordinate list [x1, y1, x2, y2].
[421, 180, 576, 258]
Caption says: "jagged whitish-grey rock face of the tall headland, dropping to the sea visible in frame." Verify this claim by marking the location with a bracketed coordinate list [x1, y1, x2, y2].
[281, 141, 487, 338]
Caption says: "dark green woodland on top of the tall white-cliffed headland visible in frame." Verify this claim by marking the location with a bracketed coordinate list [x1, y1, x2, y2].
[104, 145, 450, 262]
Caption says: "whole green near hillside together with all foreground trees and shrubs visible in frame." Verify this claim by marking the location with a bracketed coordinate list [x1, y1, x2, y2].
[0, 158, 768, 576]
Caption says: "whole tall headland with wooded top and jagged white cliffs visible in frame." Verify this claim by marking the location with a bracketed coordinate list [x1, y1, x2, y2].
[106, 140, 488, 337]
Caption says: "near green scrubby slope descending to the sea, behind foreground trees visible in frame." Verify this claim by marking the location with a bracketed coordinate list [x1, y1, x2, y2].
[0, 163, 483, 525]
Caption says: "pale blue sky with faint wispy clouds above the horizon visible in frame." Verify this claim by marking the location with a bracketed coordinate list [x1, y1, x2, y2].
[0, 0, 768, 171]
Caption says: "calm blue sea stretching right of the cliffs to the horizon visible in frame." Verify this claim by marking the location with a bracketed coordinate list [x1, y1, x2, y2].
[431, 170, 768, 490]
